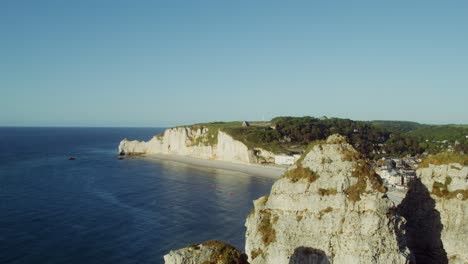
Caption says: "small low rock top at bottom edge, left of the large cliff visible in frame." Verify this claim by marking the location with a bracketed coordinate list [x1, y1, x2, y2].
[164, 240, 248, 264]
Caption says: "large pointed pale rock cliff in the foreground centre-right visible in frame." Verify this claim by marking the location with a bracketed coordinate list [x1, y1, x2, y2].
[245, 135, 406, 264]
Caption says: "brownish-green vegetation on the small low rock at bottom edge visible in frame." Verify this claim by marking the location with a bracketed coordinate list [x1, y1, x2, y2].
[197, 240, 248, 264]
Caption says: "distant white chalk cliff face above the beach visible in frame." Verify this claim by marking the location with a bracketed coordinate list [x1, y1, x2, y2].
[119, 127, 258, 163]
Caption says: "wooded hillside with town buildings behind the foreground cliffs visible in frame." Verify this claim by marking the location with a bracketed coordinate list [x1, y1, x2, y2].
[214, 116, 468, 191]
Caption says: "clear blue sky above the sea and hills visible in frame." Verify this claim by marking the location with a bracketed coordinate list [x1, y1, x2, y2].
[0, 0, 468, 126]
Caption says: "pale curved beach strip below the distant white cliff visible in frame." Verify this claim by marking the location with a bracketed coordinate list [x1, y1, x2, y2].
[140, 154, 287, 179]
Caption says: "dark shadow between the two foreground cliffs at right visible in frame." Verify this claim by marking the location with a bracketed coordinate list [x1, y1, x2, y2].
[397, 179, 448, 264]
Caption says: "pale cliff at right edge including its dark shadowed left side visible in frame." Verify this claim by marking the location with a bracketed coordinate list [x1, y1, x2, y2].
[398, 163, 468, 263]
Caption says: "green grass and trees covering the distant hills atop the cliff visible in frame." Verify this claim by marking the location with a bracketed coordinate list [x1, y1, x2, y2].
[187, 116, 468, 159]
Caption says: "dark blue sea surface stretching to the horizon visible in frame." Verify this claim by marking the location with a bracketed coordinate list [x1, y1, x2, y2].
[0, 128, 274, 263]
